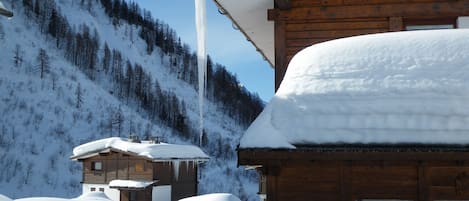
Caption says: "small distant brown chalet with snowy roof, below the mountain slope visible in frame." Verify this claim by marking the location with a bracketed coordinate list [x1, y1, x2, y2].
[70, 137, 209, 201]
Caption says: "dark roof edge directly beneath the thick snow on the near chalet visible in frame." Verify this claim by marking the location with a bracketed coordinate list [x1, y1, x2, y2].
[237, 145, 469, 166]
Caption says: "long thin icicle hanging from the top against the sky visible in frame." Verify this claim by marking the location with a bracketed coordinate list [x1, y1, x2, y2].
[195, 0, 207, 146]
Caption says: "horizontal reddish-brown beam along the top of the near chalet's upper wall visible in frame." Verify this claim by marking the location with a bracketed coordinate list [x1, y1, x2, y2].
[268, 0, 469, 20]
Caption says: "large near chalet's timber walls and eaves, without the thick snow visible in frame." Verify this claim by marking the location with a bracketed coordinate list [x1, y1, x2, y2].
[214, 0, 469, 201]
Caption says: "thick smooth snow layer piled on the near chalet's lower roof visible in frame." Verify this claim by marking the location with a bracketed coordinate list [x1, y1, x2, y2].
[240, 30, 469, 148]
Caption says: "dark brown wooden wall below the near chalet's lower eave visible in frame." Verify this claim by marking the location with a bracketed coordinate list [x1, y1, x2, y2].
[267, 161, 469, 201]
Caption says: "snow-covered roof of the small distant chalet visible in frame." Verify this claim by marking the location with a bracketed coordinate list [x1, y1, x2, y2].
[71, 137, 209, 161]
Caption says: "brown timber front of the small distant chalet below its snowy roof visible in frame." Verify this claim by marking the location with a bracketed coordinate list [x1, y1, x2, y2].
[81, 150, 198, 201]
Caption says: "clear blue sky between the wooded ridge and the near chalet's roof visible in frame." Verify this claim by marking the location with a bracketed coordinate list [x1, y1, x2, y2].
[134, 0, 274, 101]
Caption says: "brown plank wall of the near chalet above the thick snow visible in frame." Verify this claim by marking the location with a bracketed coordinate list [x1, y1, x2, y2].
[268, 0, 469, 90]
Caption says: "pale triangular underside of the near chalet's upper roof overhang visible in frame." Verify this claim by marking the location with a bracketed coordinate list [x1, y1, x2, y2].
[214, 0, 275, 65]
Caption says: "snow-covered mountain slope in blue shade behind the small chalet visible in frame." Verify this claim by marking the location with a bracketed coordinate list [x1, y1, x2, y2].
[0, 0, 257, 200]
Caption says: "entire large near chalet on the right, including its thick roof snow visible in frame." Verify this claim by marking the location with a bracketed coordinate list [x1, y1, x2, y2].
[214, 0, 469, 201]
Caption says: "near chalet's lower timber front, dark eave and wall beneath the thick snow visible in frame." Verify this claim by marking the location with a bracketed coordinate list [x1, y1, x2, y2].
[238, 146, 469, 201]
